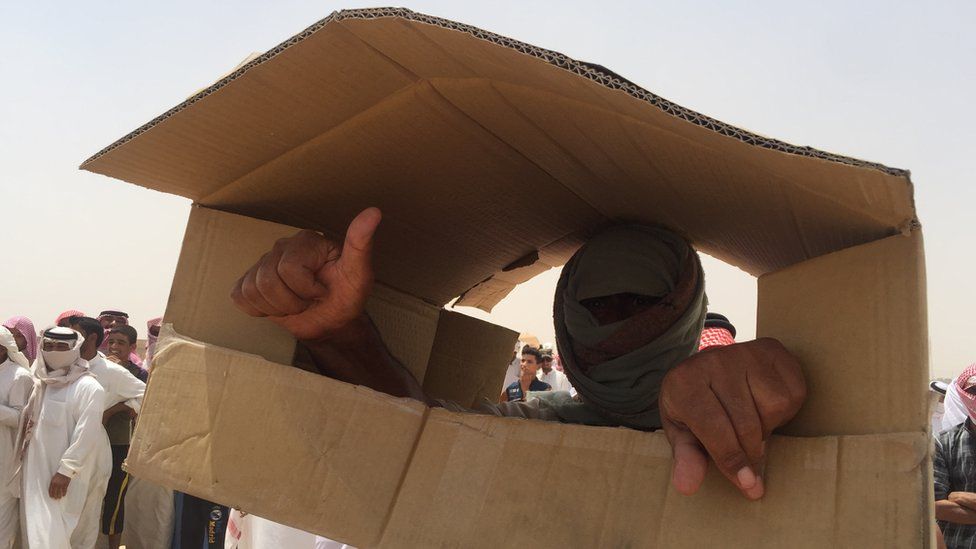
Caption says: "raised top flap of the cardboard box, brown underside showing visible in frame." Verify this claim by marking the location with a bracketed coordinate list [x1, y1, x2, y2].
[82, 9, 915, 309]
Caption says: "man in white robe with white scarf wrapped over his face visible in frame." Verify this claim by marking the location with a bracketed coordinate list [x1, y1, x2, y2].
[16, 328, 112, 549]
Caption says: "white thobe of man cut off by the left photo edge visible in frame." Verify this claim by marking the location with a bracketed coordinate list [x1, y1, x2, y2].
[0, 360, 34, 549]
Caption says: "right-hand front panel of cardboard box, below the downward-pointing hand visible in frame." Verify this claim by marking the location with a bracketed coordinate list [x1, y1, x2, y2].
[381, 409, 931, 548]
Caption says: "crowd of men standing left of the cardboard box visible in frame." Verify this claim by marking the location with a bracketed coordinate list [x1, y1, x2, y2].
[0, 310, 228, 549]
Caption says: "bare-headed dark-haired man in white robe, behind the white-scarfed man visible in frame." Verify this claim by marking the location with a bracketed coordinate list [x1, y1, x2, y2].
[71, 317, 146, 547]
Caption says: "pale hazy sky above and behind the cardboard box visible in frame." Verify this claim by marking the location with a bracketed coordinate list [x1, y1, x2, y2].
[0, 0, 976, 376]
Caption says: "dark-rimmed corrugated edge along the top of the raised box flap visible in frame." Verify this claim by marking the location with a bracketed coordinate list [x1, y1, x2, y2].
[81, 8, 910, 188]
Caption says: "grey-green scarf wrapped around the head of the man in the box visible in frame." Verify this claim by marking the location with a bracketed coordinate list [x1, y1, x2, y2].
[550, 225, 707, 430]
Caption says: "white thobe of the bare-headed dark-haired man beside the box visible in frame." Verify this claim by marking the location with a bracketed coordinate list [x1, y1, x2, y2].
[71, 353, 146, 547]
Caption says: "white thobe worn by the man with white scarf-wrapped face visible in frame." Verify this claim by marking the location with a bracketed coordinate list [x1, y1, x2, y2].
[21, 375, 112, 549]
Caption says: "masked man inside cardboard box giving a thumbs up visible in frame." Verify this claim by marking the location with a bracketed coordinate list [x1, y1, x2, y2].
[231, 208, 806, 499]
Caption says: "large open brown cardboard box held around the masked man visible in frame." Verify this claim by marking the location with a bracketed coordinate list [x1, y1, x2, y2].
[82, 8, 932, 547]
